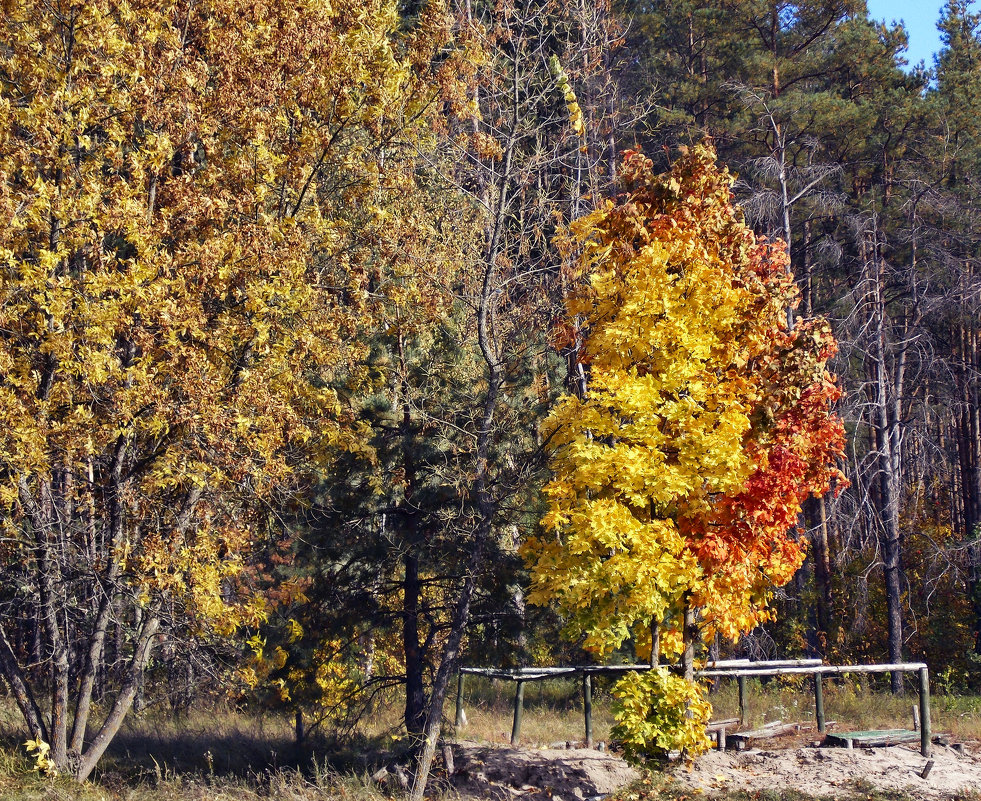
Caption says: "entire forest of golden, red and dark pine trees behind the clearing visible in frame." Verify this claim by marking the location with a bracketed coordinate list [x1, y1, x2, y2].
[0, 0, 981, 797]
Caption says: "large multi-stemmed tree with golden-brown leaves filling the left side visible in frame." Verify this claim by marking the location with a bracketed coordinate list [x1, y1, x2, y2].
[0, 0, 425, 780]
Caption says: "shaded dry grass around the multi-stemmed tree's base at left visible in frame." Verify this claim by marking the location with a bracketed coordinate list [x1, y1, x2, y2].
[0, 702, 398, 801]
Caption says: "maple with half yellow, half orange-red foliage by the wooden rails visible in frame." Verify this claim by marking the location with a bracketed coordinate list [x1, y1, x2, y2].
[526, 146, 843, 747]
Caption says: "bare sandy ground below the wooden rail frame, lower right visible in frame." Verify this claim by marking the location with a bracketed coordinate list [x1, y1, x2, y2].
[450, 740, 981, 801]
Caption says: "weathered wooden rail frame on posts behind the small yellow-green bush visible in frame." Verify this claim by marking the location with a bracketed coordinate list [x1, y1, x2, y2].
[455, 659, 931, 757]
